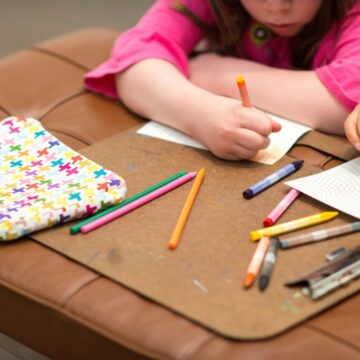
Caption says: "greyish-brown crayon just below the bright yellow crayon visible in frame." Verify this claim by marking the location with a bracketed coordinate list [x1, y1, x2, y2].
[279, 221, 360, 249]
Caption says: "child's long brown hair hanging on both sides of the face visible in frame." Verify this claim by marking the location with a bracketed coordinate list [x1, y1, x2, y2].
[172, 0, 358, 69]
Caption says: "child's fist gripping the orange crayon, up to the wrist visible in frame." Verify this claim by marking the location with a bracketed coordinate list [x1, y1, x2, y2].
[192, 95, 281, 160]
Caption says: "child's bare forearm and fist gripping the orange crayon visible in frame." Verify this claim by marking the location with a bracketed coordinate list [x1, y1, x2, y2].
[116, 59, 280, 160]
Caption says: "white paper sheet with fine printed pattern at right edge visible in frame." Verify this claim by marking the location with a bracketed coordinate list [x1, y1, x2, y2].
[285, 157, 360, 219]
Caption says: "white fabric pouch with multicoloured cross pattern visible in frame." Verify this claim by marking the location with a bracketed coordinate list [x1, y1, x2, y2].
[0, 116, 126, 240]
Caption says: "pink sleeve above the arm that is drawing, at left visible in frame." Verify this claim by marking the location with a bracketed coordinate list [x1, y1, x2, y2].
[84, 0, 212, 98]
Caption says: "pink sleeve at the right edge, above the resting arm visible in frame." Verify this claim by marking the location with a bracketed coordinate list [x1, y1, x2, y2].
[314, 5, 360, 111]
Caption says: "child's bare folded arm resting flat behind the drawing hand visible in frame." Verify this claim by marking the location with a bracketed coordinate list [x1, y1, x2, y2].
[191, 54, 348, 134]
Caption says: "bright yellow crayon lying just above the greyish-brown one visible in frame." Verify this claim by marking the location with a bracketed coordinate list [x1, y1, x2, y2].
[250, 211, 339, 241]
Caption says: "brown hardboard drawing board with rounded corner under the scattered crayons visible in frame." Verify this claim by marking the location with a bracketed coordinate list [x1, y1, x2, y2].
[32, 132, 360, 340]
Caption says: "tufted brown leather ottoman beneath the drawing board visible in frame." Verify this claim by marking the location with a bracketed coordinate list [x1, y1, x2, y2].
[0, 29, 360, 360]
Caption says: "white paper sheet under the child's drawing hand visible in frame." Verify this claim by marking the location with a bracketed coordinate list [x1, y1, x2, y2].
[137, 114, 311, 165]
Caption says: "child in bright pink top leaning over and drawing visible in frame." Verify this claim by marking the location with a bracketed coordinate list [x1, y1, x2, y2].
[85, 0, 360, 160]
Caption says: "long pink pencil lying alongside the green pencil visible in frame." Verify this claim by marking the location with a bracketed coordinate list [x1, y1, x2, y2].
[80, 172, 196, 234]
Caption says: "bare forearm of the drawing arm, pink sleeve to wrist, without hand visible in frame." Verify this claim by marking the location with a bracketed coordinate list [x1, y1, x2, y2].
[116, 59, 210, 135]
